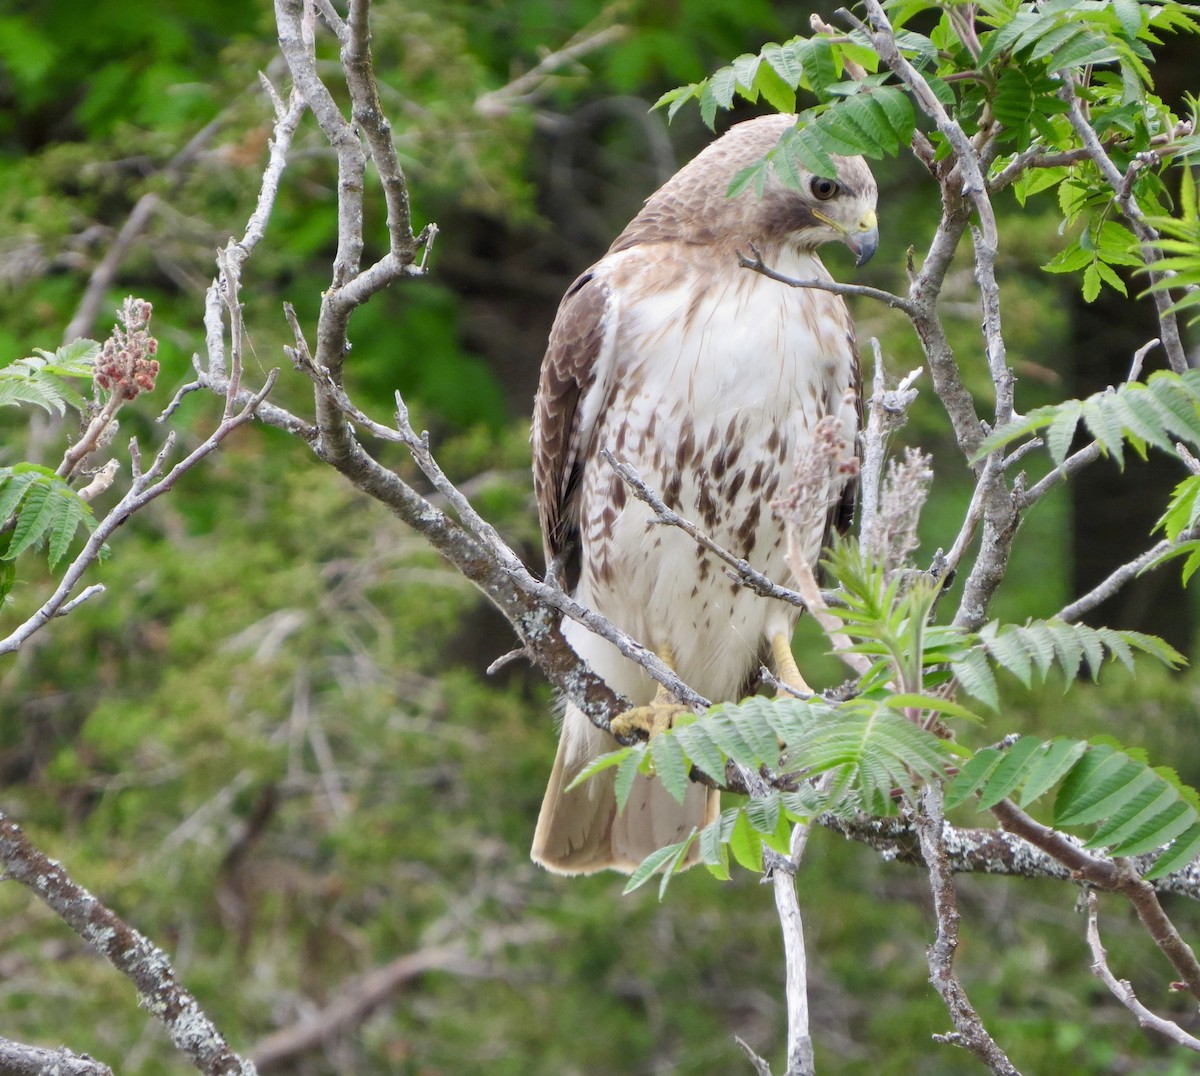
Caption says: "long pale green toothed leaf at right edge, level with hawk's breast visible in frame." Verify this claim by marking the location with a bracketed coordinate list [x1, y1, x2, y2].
[976, 369, 1200, 465]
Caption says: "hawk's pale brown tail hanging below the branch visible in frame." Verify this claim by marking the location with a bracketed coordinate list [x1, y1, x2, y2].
[530, 705, 721, 874]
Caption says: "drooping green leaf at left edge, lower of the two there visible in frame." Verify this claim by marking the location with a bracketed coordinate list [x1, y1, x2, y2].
[0, 463, 96, 575]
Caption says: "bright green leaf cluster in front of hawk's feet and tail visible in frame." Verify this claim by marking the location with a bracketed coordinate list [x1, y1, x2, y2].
[588, 542, 1184, 890]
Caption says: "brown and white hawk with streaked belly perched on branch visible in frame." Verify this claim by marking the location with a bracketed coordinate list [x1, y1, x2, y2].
[532, 115, 878, 874]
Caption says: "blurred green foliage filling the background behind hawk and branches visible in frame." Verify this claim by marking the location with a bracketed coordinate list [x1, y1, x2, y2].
[0, 0, 1200, 1076]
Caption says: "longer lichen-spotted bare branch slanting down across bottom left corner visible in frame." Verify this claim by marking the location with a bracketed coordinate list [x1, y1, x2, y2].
[0, 813, 254, 1076]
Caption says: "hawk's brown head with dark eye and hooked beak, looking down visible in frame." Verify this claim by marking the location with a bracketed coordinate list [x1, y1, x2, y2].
[613, 115, 880, 265]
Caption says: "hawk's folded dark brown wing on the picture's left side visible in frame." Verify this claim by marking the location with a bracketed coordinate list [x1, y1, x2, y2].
[532, 269, 617, 569]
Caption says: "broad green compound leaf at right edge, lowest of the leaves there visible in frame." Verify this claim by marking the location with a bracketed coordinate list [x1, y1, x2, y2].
[946, 737, 1200, 878]
